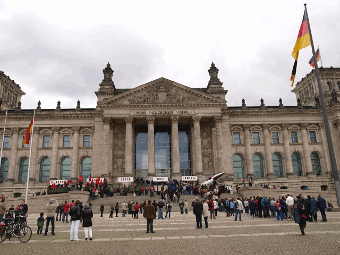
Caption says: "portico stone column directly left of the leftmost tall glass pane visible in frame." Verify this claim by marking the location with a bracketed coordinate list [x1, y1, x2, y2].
[125, 116, 133, 177]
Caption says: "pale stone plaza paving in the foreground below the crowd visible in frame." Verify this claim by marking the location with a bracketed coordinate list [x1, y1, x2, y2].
[0, 212, 340, 255]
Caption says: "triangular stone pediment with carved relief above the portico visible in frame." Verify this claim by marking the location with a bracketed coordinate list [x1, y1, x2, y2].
[98, 78, 226, 107]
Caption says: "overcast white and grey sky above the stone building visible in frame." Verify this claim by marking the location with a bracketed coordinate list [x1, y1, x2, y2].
[0, 0, 340, 109]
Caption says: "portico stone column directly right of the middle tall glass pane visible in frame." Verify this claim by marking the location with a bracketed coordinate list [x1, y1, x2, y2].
[170, 116, 182, 181]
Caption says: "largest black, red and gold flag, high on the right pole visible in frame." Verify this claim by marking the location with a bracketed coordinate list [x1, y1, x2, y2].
[290, 11, 311, 87]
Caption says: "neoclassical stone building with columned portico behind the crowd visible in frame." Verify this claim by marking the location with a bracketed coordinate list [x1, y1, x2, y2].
[0, 63, 340, 195]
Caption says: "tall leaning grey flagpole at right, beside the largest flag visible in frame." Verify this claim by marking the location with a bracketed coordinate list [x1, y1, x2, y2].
[305, 4, 340, 207]
